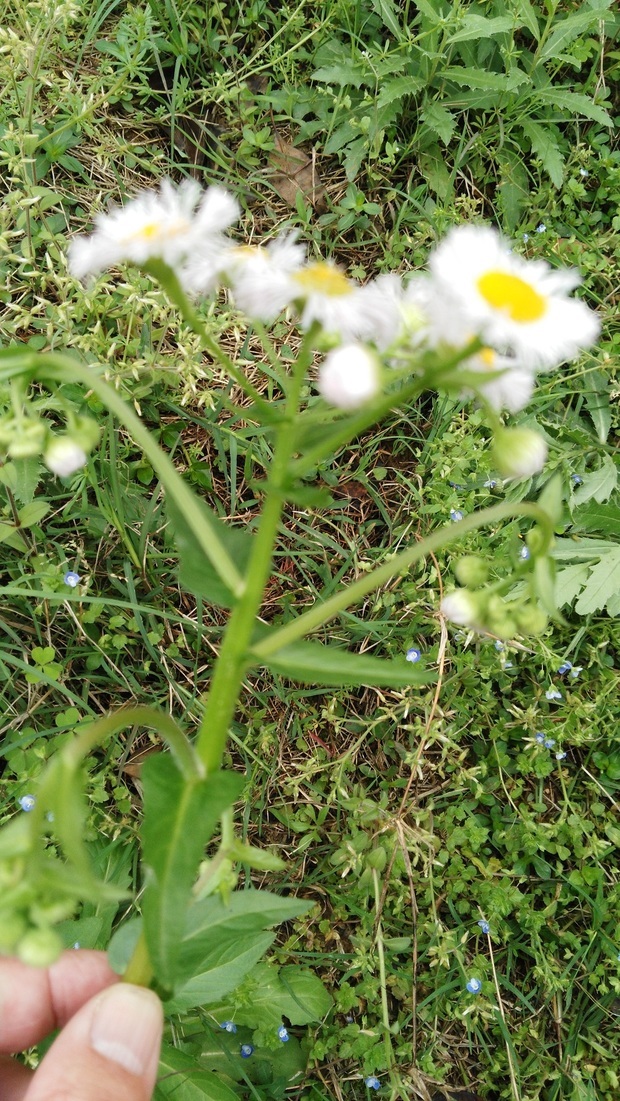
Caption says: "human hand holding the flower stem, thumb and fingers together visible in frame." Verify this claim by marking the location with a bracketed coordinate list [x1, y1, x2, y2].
[0, 950, 163, 1101]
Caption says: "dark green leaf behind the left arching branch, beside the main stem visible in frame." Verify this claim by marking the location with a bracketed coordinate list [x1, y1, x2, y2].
[166, 494, 252, 608]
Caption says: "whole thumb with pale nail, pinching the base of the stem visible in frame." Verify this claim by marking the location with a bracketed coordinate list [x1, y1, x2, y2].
[24, 982, 163, 1101]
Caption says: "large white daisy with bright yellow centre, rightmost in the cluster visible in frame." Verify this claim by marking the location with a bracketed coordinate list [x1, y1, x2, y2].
[429, 226, 599, 369]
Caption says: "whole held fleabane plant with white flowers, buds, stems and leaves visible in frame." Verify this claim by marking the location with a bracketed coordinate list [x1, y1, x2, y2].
[0, 181, 599, 1087]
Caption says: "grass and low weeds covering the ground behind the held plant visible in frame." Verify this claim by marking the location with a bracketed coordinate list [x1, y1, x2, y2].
[0, 0, 620, 1101]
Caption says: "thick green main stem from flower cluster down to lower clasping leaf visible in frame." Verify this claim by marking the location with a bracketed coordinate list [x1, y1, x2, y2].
[196, 334, 312, 773]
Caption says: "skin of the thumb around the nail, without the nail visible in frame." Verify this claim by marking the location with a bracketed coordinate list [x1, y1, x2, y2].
[23, 995, 163, 1101]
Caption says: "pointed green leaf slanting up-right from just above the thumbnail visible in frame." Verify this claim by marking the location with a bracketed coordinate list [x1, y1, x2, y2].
[167, 927, 275, 1013]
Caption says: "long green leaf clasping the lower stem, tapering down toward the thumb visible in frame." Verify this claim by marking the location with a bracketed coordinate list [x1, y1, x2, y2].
[141, 766, 244, 989]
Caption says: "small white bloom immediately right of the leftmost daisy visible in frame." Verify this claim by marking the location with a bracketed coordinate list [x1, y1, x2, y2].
[226, 233, 306, 321]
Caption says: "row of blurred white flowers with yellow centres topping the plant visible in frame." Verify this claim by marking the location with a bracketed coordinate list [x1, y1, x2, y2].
[69, 181, 599, 427]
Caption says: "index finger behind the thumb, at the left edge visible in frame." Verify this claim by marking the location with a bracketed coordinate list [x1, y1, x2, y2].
[0, 949, 118, 1055]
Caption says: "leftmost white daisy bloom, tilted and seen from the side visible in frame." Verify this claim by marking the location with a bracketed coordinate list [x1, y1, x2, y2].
[69, 179, 239, 279]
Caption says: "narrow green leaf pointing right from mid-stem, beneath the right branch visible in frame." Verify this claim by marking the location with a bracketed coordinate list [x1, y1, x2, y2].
[252, 642, 432, 688]
